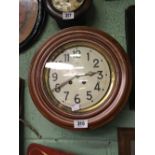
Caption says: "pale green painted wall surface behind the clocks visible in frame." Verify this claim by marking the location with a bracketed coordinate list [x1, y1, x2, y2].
[19, 0, 135, 155]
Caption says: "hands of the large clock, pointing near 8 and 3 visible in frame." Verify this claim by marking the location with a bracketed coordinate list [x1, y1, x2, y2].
[52, 71, 98, 92]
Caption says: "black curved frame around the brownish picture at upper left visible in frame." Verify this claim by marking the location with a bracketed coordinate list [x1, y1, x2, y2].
[19, 0, 46, 52]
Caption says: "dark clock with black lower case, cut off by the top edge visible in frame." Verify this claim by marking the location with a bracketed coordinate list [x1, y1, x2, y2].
[44, 0, 92, 28]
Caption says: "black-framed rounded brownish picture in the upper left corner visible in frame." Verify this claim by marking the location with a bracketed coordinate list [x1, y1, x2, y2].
[19, 0, 45, 51]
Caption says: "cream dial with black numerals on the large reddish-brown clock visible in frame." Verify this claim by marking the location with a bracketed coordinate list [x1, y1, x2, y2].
[44, 46, 112, 111]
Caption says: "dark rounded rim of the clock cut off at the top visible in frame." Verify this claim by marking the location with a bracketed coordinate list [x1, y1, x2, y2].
[44, 0, 92, 21]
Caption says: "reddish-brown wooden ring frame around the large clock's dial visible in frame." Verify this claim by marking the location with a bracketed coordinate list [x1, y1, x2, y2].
[29, 27, 132, 130]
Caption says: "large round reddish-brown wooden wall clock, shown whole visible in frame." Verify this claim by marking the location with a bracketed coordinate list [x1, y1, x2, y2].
[29, 27, 132, 130]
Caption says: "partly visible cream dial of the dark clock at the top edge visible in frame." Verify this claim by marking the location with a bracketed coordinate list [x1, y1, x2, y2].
[52, 0, 85, 12]
